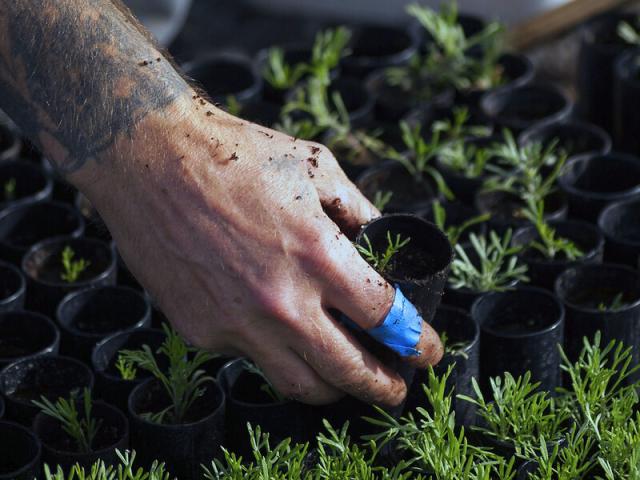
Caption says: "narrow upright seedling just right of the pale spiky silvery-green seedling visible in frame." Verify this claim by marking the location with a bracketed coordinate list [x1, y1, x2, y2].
[524, 199, 584, 261]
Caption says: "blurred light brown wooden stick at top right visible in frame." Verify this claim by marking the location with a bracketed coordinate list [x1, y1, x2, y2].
[508, 0, 631, 50]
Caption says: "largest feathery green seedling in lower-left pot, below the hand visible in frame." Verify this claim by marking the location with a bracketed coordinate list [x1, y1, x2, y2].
[120, 325, 215, 425]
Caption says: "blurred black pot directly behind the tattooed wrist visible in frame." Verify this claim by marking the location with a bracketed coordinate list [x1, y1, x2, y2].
[182, 53, 262, 104]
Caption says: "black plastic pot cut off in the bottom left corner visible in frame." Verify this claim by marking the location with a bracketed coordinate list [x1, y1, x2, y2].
[0, 421, 42, 480]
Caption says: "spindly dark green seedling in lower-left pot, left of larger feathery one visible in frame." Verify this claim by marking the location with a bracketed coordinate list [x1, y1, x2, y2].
[33, 388, 102, 453]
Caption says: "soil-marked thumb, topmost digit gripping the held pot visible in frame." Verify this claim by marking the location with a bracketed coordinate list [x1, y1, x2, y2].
[307, 143, 380, 237]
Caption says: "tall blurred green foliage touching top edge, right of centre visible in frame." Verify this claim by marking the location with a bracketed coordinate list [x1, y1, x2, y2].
[404, 2, 504, 90]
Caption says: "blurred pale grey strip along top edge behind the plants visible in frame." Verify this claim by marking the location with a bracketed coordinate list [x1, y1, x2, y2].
[242, 0, 576, 24]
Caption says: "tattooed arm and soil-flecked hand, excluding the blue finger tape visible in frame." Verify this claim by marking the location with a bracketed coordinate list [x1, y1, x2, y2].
[0, 0, 441, 404]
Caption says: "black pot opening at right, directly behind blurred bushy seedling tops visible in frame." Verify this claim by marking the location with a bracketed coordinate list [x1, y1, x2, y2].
[518, 121, 611, 157]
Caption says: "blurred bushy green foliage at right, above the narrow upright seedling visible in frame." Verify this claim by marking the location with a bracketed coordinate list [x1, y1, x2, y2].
[484, 130, 567, 208]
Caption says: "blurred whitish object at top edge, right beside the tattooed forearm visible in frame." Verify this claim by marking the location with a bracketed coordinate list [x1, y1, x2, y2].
[124, 0, 191, 47]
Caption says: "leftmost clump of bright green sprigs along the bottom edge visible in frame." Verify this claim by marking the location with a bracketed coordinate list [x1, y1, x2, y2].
[44, 451, 171, 480]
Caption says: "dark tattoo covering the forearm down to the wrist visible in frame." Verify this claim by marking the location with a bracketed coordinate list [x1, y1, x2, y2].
[0, 0, 188, 174]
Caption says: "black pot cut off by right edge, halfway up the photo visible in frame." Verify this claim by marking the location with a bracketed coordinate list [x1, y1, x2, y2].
[598, 199, 640, 268]
